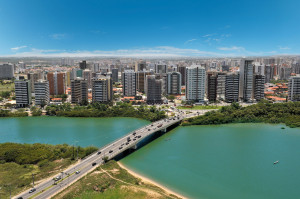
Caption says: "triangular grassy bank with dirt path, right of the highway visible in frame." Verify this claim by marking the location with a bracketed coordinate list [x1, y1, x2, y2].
[54, 161, 182, 199]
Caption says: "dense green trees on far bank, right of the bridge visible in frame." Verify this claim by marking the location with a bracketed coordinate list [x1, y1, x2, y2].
[183, 100, 300, 127]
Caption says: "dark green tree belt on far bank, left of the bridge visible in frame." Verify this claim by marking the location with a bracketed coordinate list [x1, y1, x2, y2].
[46, 102, 166, 121]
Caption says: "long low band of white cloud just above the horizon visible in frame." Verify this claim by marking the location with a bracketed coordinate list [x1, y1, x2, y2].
[0, 46, 282, 58]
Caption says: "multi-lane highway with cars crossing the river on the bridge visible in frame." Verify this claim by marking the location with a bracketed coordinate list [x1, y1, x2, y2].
[14, 111, 209, 199]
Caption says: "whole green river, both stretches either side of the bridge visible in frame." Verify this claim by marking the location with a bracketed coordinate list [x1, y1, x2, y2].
[0, 117, 300, 199]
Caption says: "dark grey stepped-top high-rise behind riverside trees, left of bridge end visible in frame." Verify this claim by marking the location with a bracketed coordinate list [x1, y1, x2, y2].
[146, 75, 162, 104]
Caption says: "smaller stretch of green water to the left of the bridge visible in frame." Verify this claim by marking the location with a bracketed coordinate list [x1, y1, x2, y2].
[0, 117, 150, 147]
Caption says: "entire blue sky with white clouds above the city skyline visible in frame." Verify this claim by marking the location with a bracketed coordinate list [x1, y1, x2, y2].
[0, 0, 300, 57]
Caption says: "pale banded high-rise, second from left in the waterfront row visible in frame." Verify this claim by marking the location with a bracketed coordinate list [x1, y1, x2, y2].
[34, 80, 50, 106]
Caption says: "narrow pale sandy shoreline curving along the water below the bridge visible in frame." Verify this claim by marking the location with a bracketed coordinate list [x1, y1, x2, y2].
[117, 161, 188, 199]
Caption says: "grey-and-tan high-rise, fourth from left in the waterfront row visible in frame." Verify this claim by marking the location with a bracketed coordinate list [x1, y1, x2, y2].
[92, 76, 113, 103]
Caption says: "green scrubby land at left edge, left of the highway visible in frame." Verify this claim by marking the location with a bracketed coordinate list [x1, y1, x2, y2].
[0, 143, 97, 198]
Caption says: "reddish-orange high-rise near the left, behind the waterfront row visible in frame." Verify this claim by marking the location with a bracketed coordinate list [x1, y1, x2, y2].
[47, 72, 66, 95]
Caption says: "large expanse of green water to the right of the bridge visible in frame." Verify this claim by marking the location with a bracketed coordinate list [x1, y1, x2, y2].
[121, 124, 300, 199]
